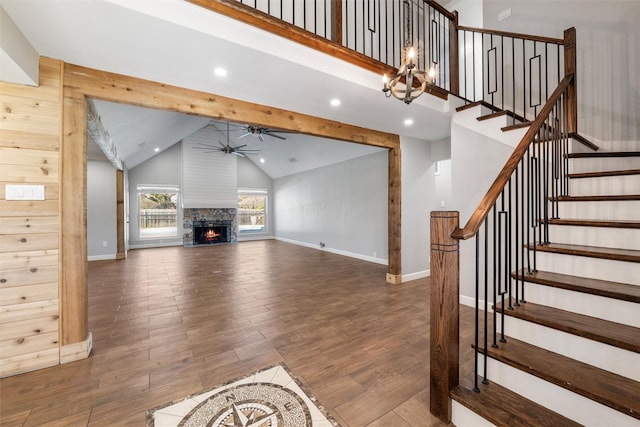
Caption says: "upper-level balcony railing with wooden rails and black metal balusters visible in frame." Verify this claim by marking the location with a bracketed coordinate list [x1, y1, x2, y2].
[188, 0, 567, 120]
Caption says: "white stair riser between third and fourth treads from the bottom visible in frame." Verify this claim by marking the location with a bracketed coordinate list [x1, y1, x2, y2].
[524, 282, 640, 328]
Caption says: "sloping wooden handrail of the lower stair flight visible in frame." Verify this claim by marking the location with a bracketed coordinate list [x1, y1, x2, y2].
[451, 74, 574, 240]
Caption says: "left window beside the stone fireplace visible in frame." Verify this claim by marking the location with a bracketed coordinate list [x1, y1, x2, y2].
[138, 185, 180, 240]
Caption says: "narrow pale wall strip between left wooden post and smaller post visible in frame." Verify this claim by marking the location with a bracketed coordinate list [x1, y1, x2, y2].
[87, 160, 117, 261]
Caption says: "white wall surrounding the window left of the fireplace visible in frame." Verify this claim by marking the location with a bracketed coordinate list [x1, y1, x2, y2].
[129, 143, 182, 247]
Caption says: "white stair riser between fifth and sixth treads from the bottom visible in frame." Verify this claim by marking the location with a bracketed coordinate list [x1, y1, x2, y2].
[549, 225, 640, 250]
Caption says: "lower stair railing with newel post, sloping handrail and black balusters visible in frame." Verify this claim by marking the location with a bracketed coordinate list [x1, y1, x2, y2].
[430, 56, 575, 427]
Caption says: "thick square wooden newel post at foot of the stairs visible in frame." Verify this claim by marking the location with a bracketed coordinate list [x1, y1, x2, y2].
[429, 211, 460, 422]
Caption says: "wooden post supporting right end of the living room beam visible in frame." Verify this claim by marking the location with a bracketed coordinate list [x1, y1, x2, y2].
[387, 147, 402, 285]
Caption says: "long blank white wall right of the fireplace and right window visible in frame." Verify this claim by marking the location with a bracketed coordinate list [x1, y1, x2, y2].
[273, 151, 388, 263]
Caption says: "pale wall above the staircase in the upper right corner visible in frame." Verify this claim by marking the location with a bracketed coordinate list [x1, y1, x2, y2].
[483, 0, 640, 140]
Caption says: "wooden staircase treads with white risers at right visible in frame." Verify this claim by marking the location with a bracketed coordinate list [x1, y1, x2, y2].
[451, 107, 640, 427]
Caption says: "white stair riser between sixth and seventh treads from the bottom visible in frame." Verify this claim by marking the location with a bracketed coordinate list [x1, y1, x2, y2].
[558, 200, 640, 221]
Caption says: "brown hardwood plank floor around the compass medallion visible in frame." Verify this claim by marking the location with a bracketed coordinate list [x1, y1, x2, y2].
[0, 241, 472, 427]
